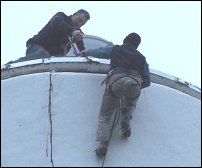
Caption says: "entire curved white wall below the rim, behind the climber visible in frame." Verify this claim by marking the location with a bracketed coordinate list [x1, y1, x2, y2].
[1, 72, 201, 167]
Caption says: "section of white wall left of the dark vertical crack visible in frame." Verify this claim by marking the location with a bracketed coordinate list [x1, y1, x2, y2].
[1, 73, 51, 167]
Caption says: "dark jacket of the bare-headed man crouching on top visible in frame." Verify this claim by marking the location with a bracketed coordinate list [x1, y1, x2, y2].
[26, 12, 85, 56]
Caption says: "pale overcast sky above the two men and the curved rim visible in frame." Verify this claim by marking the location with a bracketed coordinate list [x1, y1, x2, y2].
[1, 1, 201, 88]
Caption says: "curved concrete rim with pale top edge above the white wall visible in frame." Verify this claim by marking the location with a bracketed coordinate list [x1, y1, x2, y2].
[1, 56, 201, 100]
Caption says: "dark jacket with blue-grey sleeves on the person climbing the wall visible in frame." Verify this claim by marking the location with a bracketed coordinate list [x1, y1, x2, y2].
[87, 44, 151, 88]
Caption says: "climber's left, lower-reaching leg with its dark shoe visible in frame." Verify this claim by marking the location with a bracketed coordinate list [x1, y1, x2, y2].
[96, 76, 129, 156]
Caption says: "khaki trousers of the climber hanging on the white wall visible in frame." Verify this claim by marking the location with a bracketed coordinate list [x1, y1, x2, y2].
[97, 73, 142, 141]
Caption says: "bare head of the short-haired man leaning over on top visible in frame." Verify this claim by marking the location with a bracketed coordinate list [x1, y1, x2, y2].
[71, 9, 90, 29]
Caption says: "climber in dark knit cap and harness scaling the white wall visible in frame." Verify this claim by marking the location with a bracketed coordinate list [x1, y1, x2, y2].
[80, 33, 151, 156]
